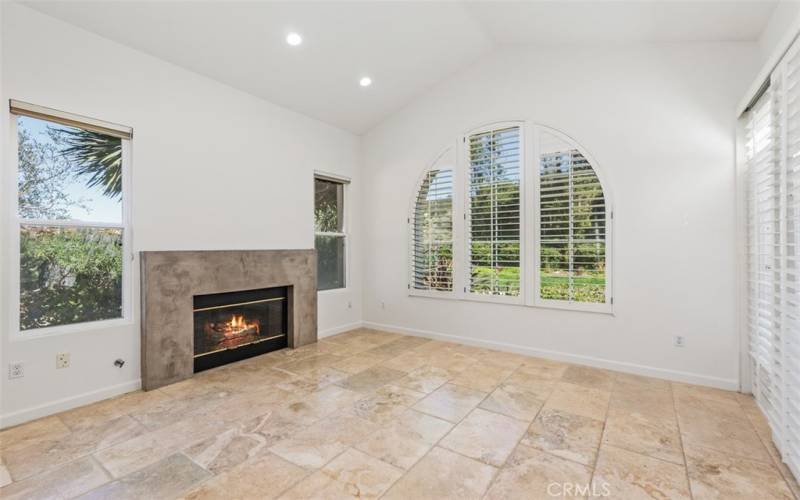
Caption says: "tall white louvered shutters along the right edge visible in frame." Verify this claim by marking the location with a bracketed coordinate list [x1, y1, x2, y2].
[744, 37, 800, 476]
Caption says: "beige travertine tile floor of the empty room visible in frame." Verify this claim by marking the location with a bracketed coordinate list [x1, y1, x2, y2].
[0, 330, 798, 500]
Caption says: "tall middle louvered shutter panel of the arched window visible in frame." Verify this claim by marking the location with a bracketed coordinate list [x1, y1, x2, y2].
[465, 126, 522, 296]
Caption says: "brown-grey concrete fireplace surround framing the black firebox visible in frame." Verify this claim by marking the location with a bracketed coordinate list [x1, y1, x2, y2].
[140, 250, 317, 391]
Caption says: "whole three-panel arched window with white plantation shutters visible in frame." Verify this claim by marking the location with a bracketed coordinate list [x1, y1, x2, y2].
[408, 121, 614, 312]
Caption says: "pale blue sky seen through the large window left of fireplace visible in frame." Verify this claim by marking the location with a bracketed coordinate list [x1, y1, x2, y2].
[17, 116, 122, 223]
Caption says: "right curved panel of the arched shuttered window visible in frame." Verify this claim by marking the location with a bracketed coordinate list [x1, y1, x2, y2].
[538, 127, 607, 303]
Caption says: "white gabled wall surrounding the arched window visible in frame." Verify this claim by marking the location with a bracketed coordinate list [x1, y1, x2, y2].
[362, 43, 758, 389]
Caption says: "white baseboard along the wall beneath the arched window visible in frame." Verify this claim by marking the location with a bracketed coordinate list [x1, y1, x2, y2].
[362, 321, 739, 391]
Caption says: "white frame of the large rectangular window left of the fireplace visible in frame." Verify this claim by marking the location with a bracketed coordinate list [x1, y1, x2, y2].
[5, 106, 135, 342]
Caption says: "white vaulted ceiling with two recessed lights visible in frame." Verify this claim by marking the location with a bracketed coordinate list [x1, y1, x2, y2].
[26, 0, 775, 133]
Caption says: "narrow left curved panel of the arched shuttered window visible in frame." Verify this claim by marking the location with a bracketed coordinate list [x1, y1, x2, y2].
[409, 150, 453, 292]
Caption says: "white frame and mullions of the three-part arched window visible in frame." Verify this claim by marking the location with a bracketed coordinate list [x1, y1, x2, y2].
[406, 119, 614, 315]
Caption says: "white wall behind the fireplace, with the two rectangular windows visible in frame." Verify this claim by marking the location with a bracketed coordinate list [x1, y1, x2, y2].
[0, 2, 362, 425]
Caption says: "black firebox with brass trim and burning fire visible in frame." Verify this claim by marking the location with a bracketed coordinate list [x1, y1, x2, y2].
[193, 287, 290, 373]
